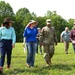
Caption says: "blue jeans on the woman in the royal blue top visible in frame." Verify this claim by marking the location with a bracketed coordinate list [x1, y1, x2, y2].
[26, 42, 37, 67]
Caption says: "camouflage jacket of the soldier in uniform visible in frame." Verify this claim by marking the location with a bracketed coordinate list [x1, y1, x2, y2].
[40, 26, 57, 45]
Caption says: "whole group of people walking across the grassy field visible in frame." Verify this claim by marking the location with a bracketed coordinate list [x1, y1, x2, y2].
[0, 17, 75, 73]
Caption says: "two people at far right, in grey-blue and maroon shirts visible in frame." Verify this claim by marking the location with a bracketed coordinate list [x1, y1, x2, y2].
[60, 22, 75, 54]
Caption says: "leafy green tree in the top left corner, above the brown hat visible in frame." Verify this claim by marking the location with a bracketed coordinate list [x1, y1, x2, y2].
[0, 1, 15, 25]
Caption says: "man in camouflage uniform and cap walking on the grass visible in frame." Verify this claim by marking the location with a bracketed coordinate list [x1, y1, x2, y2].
[40, 19, 57, 66]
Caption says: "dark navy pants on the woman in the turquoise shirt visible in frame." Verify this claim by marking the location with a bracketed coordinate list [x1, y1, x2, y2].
[0, 39, 12, 67]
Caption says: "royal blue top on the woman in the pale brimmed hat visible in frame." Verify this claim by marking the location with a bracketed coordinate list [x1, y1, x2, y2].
[24, 27, 38, 42]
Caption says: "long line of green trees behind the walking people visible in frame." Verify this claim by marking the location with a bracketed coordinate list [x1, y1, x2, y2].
[0, 1, 74, 42]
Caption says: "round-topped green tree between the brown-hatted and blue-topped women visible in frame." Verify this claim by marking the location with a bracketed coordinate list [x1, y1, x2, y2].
[15, 8, 31, 42]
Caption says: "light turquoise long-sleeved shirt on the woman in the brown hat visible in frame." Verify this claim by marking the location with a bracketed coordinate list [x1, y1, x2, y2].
[0, 27, 16, 44]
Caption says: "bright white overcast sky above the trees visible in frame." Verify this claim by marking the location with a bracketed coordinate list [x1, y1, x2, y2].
[0, 0, 75, 20]
